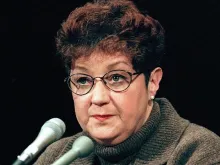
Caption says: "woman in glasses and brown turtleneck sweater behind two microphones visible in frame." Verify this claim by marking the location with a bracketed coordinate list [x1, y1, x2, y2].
[35, 0, 220, 165]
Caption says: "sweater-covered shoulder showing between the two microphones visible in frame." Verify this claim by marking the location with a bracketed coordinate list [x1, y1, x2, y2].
[34, 133, 82, 165]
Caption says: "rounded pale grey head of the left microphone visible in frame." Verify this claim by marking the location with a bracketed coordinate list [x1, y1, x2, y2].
[41, 118, 66, 140]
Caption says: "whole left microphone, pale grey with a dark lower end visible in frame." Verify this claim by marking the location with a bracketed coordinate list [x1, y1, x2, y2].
[13, 118, 66, 165]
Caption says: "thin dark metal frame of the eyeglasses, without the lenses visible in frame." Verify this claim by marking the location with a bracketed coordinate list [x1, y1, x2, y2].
[64, 70, 143, 96]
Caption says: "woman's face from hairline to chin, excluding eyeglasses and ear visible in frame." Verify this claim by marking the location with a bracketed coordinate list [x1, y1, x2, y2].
[71, 53, 152, 145]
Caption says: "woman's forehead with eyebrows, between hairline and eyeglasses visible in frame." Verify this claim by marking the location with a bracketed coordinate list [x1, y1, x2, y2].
[71, 53, 133, 72]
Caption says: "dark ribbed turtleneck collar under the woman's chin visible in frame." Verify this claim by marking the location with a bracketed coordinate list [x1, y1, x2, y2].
[94, 102, 160, 164]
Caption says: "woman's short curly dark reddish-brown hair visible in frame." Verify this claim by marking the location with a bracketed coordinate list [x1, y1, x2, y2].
[56, 0, 164, 79]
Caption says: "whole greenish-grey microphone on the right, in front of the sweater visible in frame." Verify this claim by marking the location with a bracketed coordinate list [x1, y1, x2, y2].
[52, 136, 94, 165]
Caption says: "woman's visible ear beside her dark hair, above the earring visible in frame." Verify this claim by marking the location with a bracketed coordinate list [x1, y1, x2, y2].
[148, 67, 163, 97]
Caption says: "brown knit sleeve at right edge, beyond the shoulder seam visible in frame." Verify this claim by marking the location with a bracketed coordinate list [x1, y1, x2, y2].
[169, 123, 220, 164]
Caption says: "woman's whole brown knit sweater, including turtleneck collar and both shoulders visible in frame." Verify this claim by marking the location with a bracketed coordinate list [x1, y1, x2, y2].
[34, 98, 220, 165]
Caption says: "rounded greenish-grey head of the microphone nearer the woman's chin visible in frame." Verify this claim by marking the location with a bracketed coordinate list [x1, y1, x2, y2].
[72, 136, 94, 158]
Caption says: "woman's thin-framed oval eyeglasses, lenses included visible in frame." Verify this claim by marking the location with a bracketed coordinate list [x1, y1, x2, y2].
[64, 70, 141, 96]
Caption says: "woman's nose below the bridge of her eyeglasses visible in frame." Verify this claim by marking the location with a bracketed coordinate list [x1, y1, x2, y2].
[91, 80, 110, 106]
